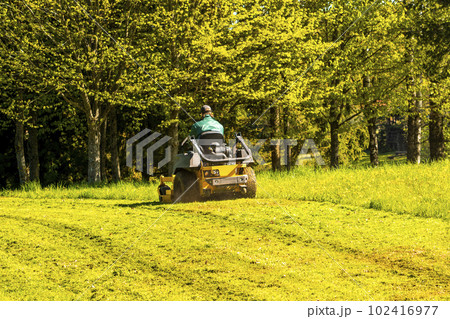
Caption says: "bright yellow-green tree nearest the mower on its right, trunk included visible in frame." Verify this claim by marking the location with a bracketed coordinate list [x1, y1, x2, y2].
[231, 1, 321, 170]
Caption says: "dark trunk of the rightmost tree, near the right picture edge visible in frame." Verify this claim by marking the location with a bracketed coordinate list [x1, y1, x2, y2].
[428, 99, 445, 161]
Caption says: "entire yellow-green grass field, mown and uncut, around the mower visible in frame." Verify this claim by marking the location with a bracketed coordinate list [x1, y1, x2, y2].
[0, 161, 450, 300]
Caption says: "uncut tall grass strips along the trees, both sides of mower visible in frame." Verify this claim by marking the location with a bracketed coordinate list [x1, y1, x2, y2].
[0, 160, 450, 220]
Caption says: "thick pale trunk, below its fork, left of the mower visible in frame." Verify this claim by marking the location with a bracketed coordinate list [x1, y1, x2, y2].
[88, 118, 101, 183]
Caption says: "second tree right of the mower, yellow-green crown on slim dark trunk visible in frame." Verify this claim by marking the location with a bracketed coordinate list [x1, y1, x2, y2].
[298, 1, 383, 168]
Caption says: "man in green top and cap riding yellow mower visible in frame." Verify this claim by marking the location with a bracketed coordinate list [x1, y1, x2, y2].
[158, 105, 256, 203]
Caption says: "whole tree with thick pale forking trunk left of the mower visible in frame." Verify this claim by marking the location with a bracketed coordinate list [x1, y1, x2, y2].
[15, 1, 145, 182]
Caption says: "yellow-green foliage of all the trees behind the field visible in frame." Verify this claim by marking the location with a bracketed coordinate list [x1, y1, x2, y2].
[0, 0, 450, 185]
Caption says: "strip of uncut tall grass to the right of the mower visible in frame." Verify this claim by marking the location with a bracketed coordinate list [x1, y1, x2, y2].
[257, 160, 450, 219]
